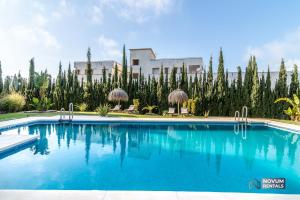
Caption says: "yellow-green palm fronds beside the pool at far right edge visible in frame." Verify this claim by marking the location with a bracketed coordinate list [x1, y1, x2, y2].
[274, 94, 300, 121]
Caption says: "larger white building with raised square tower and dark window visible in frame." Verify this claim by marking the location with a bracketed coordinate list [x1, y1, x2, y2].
[129, 48, 203, 78]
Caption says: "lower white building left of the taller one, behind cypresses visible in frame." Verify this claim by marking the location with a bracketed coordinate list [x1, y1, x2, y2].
[74, 60, 122, 82]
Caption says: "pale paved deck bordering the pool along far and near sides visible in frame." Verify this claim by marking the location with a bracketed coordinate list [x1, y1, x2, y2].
[0, 115, 300, 200]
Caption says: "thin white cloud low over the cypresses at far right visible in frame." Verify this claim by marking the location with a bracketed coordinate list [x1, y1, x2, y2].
[245, 27, 300, 70]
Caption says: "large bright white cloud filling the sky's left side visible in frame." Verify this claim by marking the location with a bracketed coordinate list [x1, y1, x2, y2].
[0, 0, 61, 76]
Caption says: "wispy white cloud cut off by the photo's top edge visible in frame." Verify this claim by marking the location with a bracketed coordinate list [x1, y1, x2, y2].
[98, 0, 179, 23]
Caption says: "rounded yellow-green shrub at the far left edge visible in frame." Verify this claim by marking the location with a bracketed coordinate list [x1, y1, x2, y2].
[0, 92, 25, 112]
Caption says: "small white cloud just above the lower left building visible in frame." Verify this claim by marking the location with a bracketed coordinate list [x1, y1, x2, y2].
[97, 35, 122, 60]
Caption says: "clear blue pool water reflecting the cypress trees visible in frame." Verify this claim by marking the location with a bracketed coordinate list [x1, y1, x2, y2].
[0, 123, 300, 194]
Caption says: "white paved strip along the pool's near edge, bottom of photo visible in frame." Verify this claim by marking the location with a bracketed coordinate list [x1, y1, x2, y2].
[0, 190, 300, 200]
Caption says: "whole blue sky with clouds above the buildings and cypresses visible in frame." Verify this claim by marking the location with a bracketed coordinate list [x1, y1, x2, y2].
[0, 0, 300, 76]
